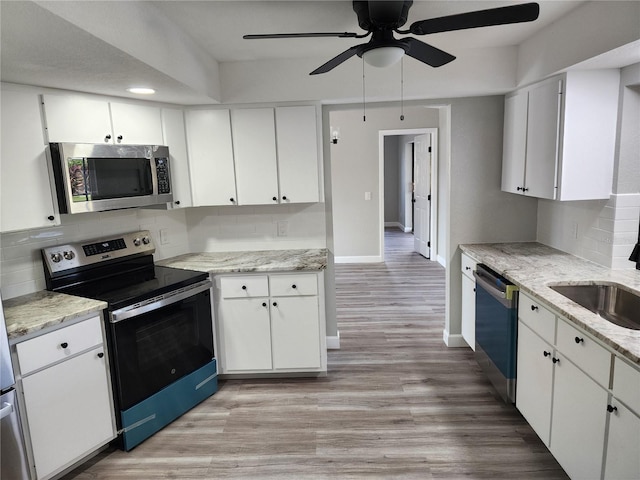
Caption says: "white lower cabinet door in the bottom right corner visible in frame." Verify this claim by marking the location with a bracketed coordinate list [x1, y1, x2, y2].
[604, 398, 640, 480]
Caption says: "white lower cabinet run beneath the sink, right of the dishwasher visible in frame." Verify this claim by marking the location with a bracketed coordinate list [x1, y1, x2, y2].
[516, 292, 640, 480]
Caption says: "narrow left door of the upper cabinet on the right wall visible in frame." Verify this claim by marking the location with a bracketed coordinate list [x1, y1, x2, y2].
[502, 92, 528, 193]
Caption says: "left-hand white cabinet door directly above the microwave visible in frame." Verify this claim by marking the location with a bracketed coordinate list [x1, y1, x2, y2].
[43, 95, 113, 143]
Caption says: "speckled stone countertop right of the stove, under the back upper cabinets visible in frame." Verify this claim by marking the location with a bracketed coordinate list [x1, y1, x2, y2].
[156, 249, 327, 273]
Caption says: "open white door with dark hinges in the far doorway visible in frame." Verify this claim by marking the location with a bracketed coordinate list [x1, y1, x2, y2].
[413, 133, 431, 258]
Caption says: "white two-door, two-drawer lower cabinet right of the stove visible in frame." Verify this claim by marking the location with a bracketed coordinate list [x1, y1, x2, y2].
[215, 273, 326, 374]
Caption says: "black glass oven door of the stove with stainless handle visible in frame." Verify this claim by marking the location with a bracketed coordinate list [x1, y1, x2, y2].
[109, 280, 214, 410]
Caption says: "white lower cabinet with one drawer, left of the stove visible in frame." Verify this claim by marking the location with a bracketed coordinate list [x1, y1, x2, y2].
[16, 317, 116, 479]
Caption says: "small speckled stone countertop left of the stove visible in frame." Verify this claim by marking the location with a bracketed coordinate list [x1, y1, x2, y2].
[3, 290, 107, 340]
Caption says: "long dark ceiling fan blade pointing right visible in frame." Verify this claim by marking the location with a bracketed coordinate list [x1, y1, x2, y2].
[400, 3, 540, 35]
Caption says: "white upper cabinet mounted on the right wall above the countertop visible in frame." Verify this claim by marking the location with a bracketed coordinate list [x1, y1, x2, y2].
[502, 70, 620, 200]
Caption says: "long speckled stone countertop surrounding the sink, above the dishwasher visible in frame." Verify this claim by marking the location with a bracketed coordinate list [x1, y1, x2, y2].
[460, 243, 640, 364]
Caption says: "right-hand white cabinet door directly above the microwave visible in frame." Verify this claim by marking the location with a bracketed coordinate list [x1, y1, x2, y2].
[111, 102, 164, 145]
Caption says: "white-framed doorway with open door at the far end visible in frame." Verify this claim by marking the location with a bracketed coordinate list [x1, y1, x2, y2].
[378, 128, 438, 261]
